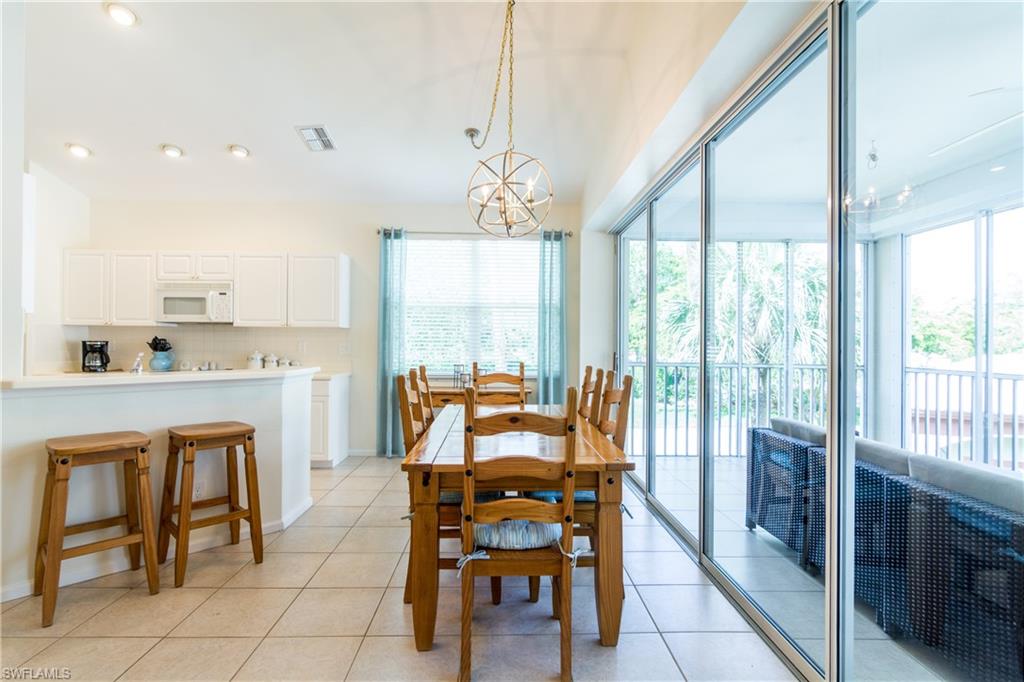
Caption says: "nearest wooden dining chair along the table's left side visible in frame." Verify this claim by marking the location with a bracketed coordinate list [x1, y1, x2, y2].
[395, 367, 502, 604]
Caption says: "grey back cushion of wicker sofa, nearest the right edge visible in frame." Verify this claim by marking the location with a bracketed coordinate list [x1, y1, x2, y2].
[910, 457, 1024, 514]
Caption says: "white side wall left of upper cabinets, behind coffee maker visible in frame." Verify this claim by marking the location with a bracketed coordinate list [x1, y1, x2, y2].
[25, 163, 89, 374]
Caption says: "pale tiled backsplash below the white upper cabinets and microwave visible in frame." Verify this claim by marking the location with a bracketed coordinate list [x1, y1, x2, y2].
[89, 325, 351, 370]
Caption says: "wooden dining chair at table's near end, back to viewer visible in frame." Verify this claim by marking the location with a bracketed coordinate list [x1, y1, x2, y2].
[459, 388, 579, 682]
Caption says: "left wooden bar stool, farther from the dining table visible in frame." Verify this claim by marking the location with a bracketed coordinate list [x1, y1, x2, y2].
[33, 431, 160, 628]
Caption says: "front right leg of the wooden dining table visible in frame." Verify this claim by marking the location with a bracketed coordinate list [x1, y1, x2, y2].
[594, 471, 625, 646]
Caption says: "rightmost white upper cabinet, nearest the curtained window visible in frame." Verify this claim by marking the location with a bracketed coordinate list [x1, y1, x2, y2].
[288, 254, 350, 327]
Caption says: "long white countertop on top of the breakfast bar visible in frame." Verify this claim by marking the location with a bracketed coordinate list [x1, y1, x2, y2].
[0, 367, 321, 390]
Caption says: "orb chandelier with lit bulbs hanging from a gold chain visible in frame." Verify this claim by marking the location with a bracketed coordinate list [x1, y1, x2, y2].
[466, 0, 555, 239]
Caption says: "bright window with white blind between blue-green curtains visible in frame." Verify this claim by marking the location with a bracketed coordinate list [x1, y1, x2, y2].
[404, 239, 540, 376]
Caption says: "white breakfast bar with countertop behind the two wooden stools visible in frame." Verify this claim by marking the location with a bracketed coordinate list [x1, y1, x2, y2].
[0, 367, 319, 600]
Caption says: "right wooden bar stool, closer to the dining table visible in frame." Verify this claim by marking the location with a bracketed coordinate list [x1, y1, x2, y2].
[157, 422, 263, 587]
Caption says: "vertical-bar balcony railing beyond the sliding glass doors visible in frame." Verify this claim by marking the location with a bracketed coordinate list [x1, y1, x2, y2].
[626, 363, 1024, 470]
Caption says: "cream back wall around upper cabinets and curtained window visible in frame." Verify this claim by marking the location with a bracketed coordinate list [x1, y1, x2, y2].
[90, 200, 580, 453]
